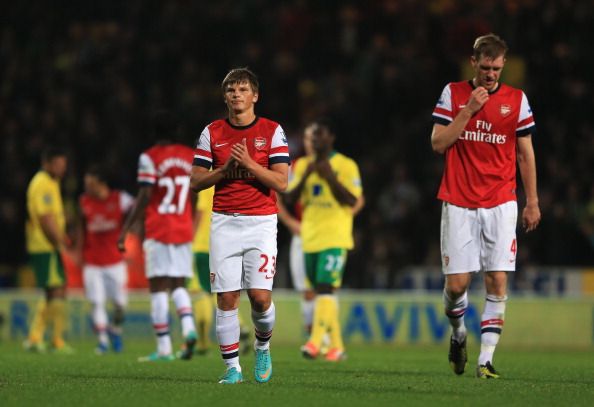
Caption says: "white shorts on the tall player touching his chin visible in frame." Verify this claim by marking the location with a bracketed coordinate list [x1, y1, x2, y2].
[441, 201, 518, 274]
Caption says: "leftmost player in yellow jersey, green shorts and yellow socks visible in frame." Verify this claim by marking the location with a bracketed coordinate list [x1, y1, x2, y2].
[25, 147, 72, 353]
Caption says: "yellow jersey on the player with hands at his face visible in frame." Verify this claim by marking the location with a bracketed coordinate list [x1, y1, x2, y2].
[289, 152, 363, 253]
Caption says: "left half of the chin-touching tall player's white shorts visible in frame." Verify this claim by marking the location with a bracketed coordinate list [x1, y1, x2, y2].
[440, 202, 481, 274]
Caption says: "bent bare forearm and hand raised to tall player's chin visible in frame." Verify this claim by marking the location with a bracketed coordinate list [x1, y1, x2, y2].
[431, 86, 489, 154]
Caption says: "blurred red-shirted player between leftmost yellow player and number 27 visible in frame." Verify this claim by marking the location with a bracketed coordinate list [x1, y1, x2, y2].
[77, 166, 134, 355]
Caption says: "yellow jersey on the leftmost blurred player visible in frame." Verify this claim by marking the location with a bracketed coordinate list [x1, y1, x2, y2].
[26, 171, 66, 253]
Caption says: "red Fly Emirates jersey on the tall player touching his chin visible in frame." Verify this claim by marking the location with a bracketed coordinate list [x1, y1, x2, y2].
[433, 81, 535, 208]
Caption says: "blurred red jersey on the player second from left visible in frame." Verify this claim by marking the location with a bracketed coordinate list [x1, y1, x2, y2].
[79, 190, 134, 266]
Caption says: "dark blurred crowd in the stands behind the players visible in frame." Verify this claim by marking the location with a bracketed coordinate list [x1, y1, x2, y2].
[0, 0, 594, 288]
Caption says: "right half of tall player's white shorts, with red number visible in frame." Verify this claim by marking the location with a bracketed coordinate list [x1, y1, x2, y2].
[480, 201, 518, 271]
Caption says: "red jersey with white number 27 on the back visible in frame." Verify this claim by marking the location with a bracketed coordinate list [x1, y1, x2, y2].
[138, 144, 194, 244]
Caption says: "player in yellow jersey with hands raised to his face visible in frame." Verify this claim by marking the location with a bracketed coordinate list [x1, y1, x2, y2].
[286, 120, 363, 361]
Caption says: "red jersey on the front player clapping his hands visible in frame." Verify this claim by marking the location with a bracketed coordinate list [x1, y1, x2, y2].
[194, 117, 289, 215]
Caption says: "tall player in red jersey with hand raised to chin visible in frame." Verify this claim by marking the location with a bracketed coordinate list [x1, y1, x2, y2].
[431, 34, 540, 379]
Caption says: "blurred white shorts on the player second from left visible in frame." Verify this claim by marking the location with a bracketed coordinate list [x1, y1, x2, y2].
[83, 261, 128, 307]
